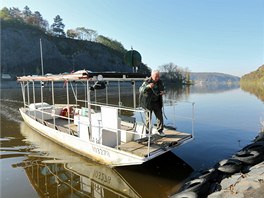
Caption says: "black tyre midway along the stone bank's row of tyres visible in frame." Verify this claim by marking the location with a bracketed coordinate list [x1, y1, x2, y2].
[217, 159, 242, 174]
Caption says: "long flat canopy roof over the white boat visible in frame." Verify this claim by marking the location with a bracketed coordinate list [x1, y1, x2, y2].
[17, 70, 147, 82]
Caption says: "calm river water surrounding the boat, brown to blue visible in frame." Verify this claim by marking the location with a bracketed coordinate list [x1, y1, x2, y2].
[0, 82, 264, 198]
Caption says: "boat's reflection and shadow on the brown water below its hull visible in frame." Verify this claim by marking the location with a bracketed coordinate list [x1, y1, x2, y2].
[17, 122, 193, 197]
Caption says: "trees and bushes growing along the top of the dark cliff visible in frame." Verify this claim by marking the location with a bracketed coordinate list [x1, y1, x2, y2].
[0, 6, 127, 53]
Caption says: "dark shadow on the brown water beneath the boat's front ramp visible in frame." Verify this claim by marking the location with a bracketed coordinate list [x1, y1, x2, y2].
[116, 152, 193, 197]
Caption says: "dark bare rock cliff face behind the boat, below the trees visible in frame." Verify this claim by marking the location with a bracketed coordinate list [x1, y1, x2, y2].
[1, 21, 132, 75]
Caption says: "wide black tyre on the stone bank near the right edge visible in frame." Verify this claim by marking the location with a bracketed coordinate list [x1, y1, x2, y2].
[233, 150, 263, 165]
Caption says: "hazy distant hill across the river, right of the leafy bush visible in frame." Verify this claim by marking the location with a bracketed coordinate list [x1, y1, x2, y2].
[190, 72, 240, 84]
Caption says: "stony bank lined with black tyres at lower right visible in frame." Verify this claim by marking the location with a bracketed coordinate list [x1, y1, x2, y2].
[171, 130, 264, 198]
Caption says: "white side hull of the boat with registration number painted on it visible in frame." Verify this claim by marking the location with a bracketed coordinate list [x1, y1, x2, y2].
[19, 108, 147, 166]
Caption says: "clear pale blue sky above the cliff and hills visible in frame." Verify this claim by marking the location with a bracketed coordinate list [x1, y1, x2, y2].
[0, 0, 264, 76]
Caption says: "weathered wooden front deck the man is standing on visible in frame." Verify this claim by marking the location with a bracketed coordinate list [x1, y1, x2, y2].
[118, 130, 192, 157]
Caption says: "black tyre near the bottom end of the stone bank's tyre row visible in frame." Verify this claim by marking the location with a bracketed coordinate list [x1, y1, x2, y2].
[180, 178, 209, 194]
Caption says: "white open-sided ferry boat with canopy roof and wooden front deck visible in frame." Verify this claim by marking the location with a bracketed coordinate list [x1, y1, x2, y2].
[17, 70, 194, 167]
